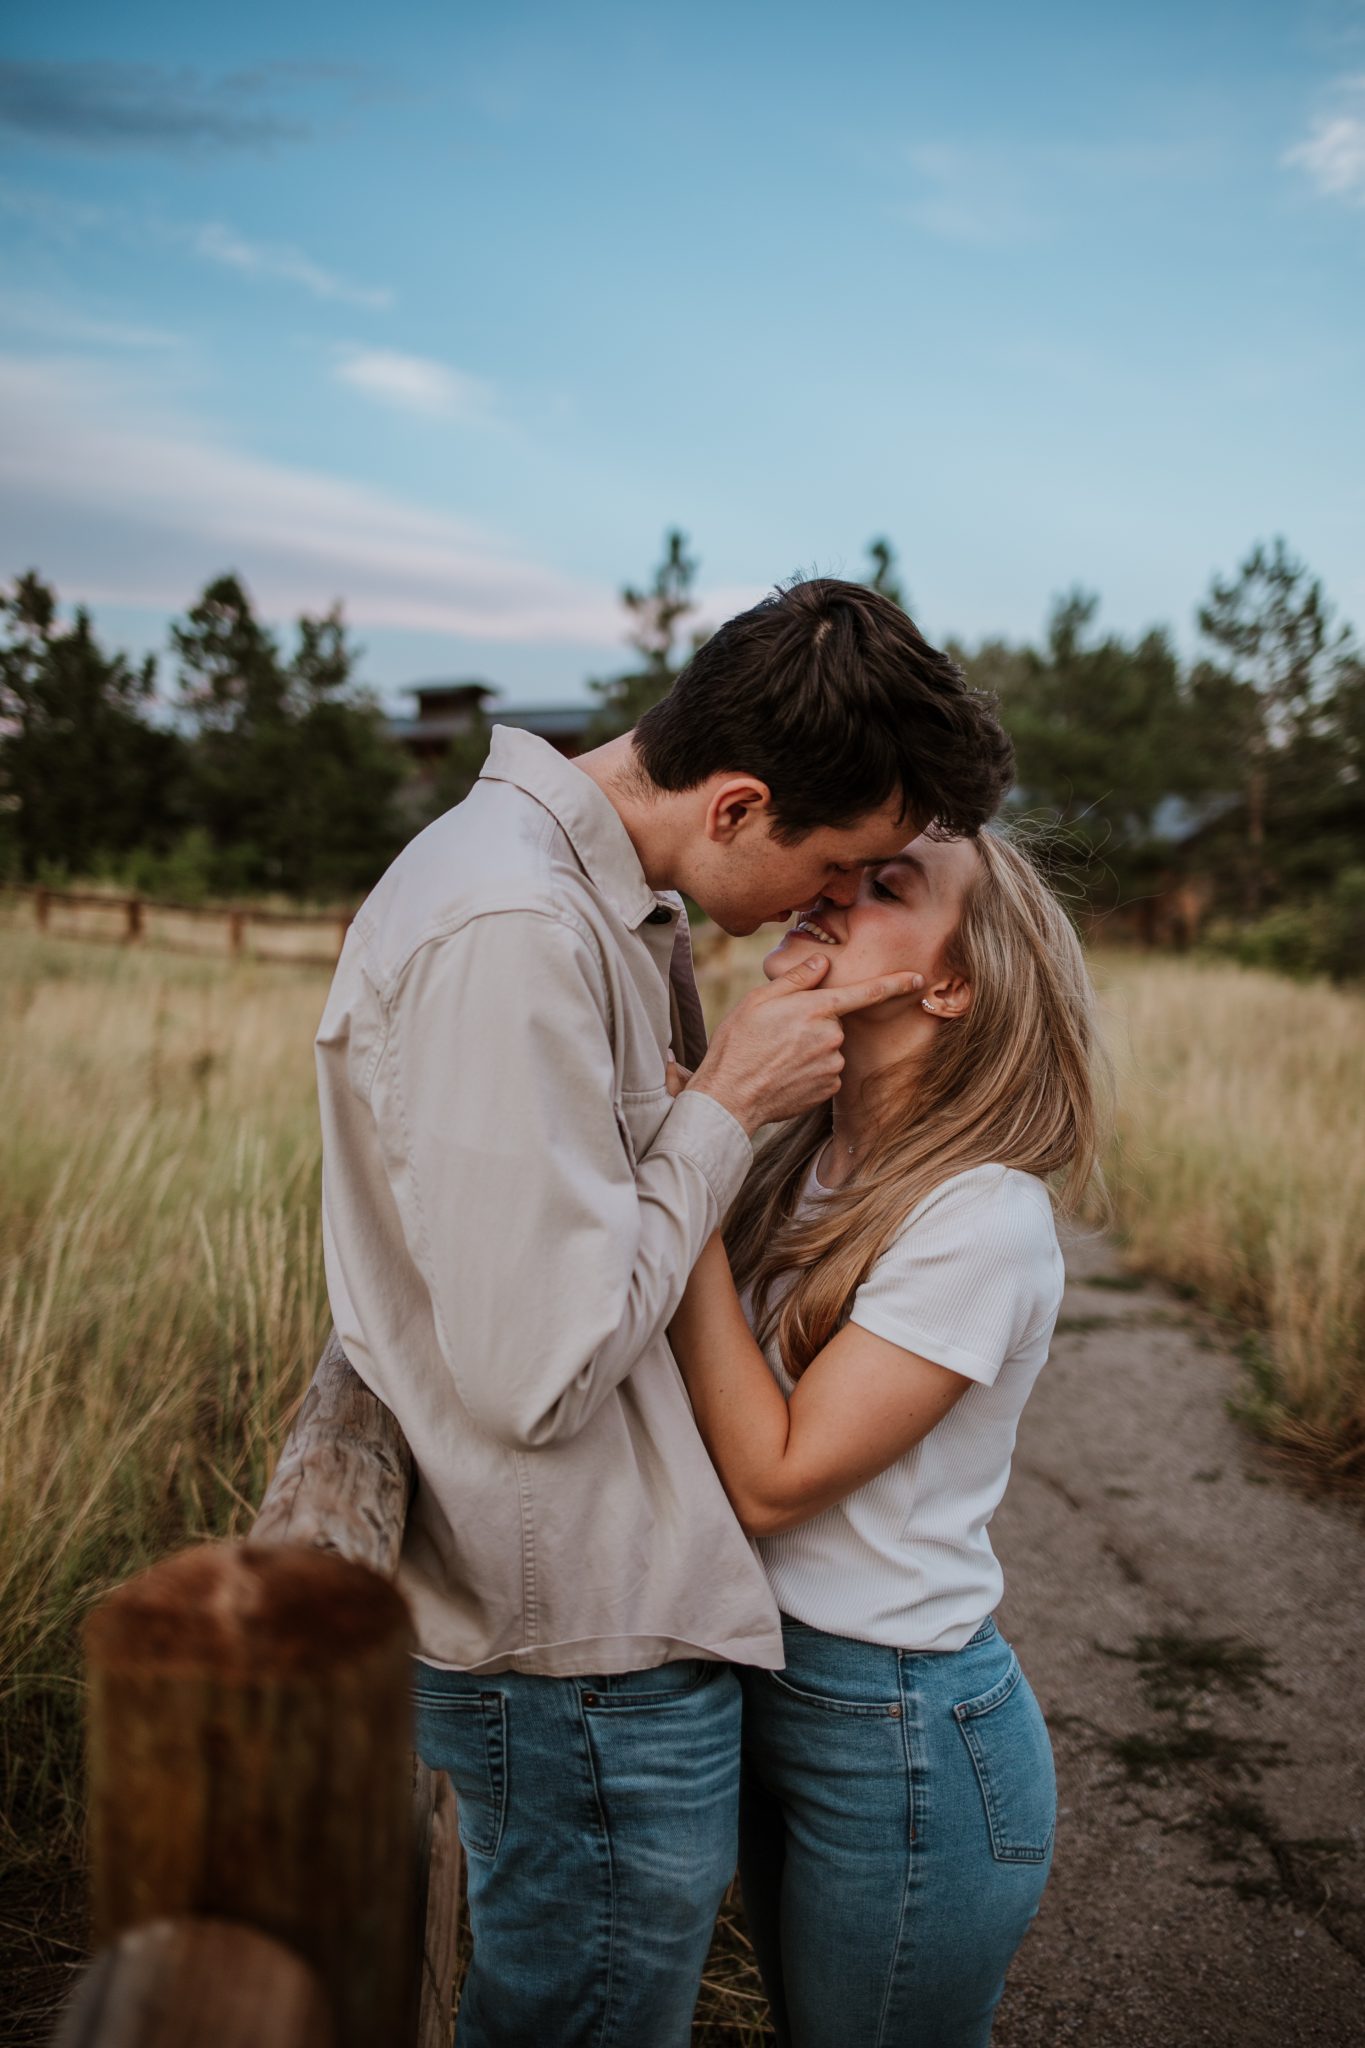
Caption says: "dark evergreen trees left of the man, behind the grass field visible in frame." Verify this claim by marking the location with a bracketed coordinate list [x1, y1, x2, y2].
[0, 573, 411, 899]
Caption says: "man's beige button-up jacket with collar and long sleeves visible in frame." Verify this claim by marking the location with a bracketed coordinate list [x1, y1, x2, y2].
[317, 727, 782, 1673]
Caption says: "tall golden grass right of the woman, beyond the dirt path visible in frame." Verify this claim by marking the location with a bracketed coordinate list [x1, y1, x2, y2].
[1097, 954, 1365, 1475]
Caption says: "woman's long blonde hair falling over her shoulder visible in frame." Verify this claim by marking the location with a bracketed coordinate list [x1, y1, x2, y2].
[724, 831, 1107, 1378]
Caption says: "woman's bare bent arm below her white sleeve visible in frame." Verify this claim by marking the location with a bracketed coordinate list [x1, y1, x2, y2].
[669, 1235, 972, 1536]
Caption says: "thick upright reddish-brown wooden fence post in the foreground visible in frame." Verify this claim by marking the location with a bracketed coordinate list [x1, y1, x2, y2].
[86, 1544, 415, 2048]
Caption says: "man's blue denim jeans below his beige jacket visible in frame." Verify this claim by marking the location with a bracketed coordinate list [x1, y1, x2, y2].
[413, 1659, 741, 2048]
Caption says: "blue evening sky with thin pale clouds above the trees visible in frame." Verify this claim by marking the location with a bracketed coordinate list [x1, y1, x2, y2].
[0, 0, 1365, 700]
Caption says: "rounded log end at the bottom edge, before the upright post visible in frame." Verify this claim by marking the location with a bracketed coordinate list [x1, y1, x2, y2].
[55, 1919, 336, 2048]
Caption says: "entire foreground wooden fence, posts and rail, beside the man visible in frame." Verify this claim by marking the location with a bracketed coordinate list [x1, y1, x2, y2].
[55, 1333, 460, 2048]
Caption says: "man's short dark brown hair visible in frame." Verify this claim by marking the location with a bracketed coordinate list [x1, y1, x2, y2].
[634, 575, 1013, 844]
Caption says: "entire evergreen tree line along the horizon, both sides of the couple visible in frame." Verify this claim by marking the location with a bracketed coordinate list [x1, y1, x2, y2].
[0, 532, 1365, 973]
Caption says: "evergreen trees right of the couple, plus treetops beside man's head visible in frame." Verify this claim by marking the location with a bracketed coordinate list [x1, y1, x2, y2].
[593, 532, 1365, 979]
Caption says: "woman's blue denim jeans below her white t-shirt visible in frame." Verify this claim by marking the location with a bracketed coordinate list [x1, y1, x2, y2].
[739, 1620, 1056, 2048]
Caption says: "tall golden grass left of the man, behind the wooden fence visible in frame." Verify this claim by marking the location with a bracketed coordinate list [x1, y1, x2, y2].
[0, 930, 325, 1851]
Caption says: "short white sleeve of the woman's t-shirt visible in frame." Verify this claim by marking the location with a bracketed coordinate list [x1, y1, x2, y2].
[849, 1167, 1062, 1386]
